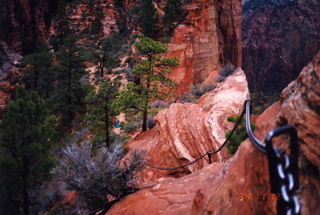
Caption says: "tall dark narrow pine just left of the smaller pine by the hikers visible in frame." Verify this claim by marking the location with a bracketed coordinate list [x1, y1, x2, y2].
[52, 35, 88, 124]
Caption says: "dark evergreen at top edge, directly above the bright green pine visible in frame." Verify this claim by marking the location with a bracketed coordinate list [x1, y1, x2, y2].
[139, 0, 159, 38]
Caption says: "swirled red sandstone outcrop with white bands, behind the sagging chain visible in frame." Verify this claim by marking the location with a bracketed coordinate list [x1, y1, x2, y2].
[128, 69, 248, 182]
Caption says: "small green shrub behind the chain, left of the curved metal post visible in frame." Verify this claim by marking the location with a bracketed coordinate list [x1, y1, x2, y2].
[225, 116, 256, 154]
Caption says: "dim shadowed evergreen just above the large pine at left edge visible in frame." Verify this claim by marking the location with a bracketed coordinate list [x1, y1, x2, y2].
[21, 40, 54, 99]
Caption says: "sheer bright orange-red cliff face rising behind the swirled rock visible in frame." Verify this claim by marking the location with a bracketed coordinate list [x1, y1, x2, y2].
[168, 0, 242, 92]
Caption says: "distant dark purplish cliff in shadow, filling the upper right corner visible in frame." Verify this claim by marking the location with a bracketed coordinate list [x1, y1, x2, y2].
[242, 0, 320, 91]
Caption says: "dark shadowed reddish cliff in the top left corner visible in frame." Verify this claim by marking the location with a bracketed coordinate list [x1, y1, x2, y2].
[0, 0, 54, 54]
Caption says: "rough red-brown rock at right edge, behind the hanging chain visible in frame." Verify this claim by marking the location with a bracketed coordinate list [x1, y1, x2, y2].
[278, 51, 320, 169]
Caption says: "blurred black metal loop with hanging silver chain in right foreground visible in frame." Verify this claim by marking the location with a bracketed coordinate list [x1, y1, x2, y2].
[265, 125, 301, 215]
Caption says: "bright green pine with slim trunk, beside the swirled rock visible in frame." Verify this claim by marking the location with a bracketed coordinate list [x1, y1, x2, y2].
[119, 37, 179, 131]
